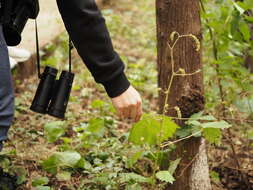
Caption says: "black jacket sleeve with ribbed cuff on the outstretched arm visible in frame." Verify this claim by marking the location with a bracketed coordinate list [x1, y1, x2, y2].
[57, 0, 130, 97]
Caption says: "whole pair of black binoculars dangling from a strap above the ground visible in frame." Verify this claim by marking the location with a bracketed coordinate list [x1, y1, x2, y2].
[30, 66, 74, 119]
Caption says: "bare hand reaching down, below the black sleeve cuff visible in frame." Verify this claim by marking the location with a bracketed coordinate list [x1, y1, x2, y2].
[112, 86, 142, 122]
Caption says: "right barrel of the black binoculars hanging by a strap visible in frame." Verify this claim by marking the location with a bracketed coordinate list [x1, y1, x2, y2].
[48, 71, 74, 119]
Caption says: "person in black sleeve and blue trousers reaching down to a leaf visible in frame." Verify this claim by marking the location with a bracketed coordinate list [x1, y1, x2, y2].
[0, 0, 142, 153]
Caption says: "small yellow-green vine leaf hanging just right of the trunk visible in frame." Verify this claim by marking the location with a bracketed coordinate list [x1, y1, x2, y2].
[203, 128, 222, 145]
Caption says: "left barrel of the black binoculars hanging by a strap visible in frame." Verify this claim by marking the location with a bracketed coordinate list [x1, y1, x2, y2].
[30, 67, 58, 114]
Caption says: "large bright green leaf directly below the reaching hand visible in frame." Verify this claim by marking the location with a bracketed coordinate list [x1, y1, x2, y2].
[129, 114, 179, 145]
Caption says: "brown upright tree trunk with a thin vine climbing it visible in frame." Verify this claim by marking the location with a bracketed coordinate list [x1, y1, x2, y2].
[156, 0, 211, 190]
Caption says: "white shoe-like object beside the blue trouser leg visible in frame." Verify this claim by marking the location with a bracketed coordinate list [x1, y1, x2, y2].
[8, 47, 31, 62]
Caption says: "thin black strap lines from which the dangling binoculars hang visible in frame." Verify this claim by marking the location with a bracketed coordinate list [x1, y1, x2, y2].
[35, 19, 74, 78]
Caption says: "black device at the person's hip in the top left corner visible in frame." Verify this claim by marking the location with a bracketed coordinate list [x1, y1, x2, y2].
[3, 0, 39, 46]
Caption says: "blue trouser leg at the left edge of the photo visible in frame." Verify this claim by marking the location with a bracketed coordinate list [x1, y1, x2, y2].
[0, 24, 14, 145]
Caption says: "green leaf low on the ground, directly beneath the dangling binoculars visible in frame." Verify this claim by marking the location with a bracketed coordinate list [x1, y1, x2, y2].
[44, 121, 65, 143]
